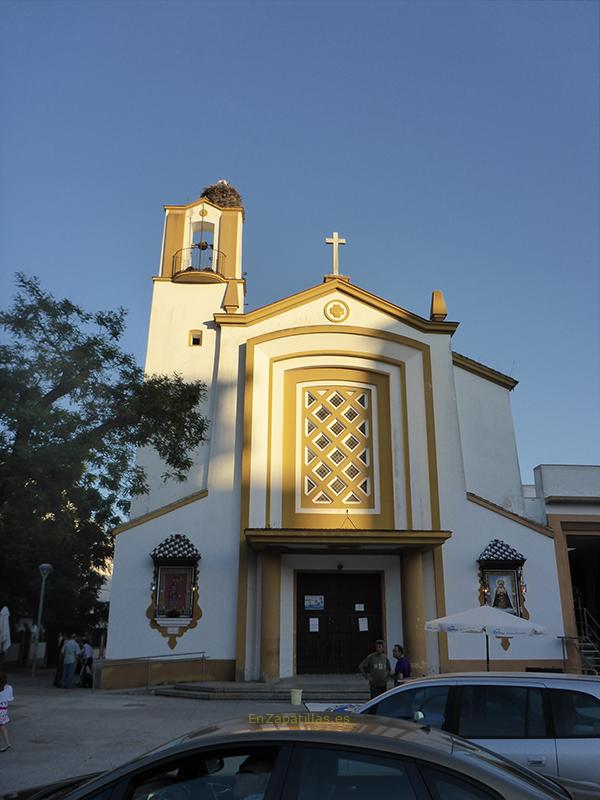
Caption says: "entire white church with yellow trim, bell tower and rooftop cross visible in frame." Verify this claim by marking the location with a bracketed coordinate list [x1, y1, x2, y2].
[102, 183, 600, 688]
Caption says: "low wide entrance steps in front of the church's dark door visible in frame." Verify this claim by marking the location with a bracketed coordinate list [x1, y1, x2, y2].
[154, 675, 369, 704]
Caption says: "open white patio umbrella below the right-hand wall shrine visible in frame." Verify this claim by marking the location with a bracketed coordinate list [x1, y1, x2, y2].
[425, 606, 546, 672]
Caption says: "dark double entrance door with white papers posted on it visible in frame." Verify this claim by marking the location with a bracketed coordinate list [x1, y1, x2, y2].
[296, 572, 383, 674]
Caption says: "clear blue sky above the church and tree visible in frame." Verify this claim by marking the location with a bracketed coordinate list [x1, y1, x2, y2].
[0, 0, 600, 482]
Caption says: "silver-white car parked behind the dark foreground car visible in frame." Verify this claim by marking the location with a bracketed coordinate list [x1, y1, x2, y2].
[357, 672, 600, 783]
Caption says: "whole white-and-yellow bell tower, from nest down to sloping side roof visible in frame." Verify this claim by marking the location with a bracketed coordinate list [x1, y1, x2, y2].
[131, 181, 245, 510]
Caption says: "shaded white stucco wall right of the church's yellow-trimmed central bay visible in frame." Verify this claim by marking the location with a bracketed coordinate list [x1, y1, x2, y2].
[432, 342, 563, 660]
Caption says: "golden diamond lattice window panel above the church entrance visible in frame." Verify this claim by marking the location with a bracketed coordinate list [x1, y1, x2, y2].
[301, 385, 374, 510]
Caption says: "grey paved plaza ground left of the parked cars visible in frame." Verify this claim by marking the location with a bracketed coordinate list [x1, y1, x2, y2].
[0, 670, 298, 793]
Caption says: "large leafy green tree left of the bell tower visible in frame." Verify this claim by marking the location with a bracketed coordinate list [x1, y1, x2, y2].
[0, 273, 208, 629]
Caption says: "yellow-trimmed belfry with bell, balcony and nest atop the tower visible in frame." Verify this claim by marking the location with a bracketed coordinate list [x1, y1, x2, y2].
[160, 180, 245, 314]
